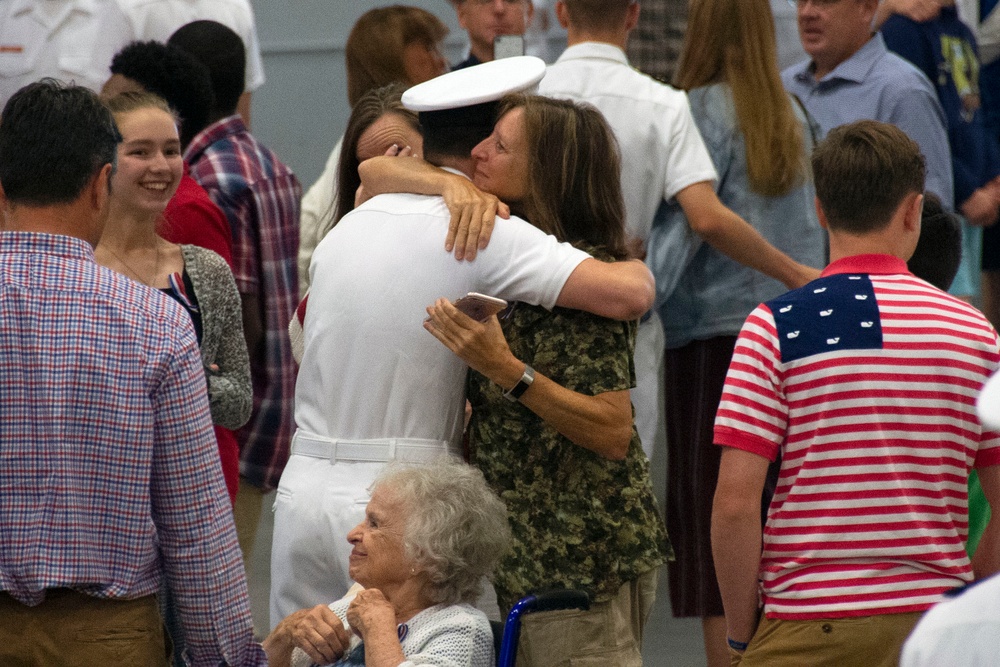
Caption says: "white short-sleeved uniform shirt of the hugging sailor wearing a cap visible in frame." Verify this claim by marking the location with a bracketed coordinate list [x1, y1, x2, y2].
[295, 188, 590, 443]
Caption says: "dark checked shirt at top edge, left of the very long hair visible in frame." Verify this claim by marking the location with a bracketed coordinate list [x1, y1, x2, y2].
[626, 0, 688, 83]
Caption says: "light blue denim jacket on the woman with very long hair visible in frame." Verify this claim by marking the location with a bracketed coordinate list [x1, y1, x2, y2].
[646, 84, 827, 348]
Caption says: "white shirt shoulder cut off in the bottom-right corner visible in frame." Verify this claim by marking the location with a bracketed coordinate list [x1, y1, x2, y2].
[899, 576, 1000, 667]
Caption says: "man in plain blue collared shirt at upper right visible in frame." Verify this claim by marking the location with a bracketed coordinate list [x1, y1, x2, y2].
[782, 0, 954, 205]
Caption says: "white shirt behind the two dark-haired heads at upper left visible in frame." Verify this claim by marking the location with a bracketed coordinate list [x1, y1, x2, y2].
[105, 0, 264, 92]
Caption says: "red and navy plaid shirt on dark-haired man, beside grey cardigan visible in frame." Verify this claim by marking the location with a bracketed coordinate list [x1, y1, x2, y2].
[185, 116, 302, 491]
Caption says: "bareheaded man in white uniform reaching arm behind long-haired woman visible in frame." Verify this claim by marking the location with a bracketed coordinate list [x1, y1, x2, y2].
[539, 0, 818, 468]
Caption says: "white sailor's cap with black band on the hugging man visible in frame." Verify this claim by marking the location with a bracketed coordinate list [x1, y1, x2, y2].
[403, 56, 545, 131]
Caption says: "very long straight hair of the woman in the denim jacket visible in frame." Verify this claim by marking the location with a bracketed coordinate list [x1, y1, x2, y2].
[674, 0, 808, 197]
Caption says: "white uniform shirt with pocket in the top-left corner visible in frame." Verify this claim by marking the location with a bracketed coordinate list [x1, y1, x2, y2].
[0, 0, 128, 108]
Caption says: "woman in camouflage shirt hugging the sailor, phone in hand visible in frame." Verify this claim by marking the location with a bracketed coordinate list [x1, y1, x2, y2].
[425, 96, 669, 666]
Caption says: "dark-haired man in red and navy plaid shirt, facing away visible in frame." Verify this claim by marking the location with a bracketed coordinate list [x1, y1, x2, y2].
[168, 21, 302, 556]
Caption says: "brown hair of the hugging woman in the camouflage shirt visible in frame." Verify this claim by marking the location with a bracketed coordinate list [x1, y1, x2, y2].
[498, 95, 628, 259]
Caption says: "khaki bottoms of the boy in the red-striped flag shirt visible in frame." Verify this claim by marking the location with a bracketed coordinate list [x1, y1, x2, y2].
[731, 612, 923, 667]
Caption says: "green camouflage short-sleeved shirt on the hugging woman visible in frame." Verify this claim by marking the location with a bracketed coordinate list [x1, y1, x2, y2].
[469, 258, 670, 609]
